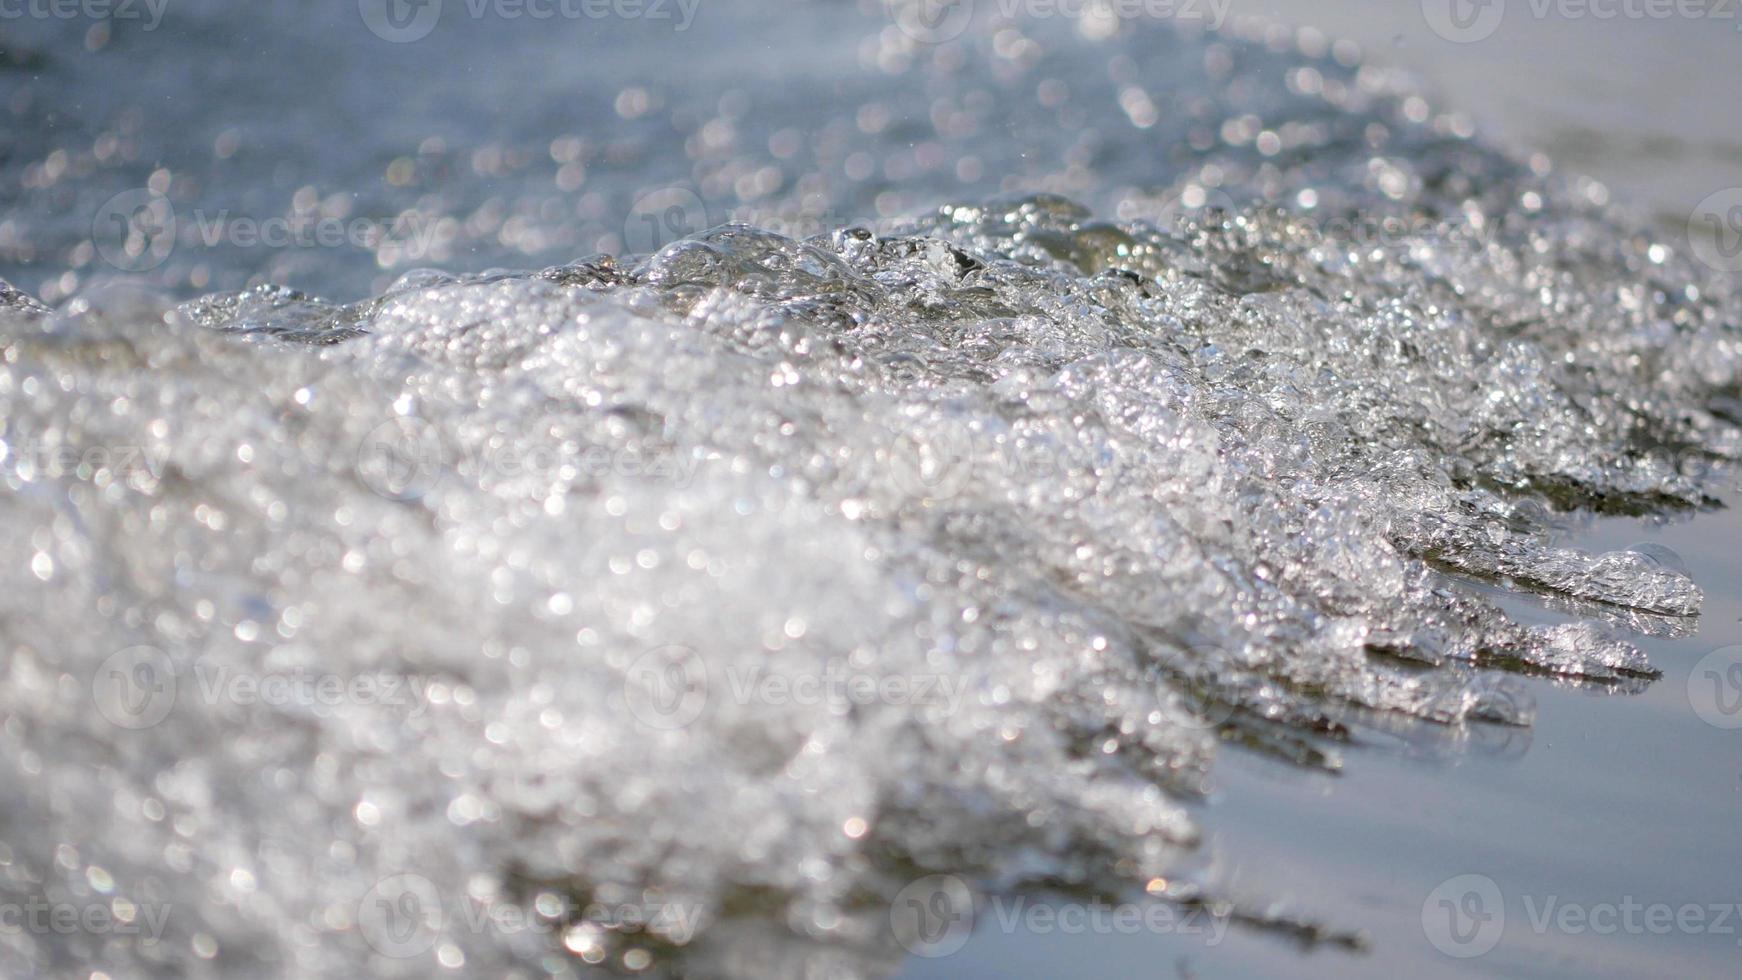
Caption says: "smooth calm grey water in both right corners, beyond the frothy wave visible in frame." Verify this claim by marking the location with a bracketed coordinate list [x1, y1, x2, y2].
[902, 0, 1742, 980]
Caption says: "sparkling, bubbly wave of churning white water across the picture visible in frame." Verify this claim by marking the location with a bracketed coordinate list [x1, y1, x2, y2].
[0, 5, 1742, 977]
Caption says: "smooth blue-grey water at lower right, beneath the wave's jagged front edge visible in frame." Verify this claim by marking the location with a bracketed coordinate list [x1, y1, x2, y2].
[902, 493, 1742, 978]
